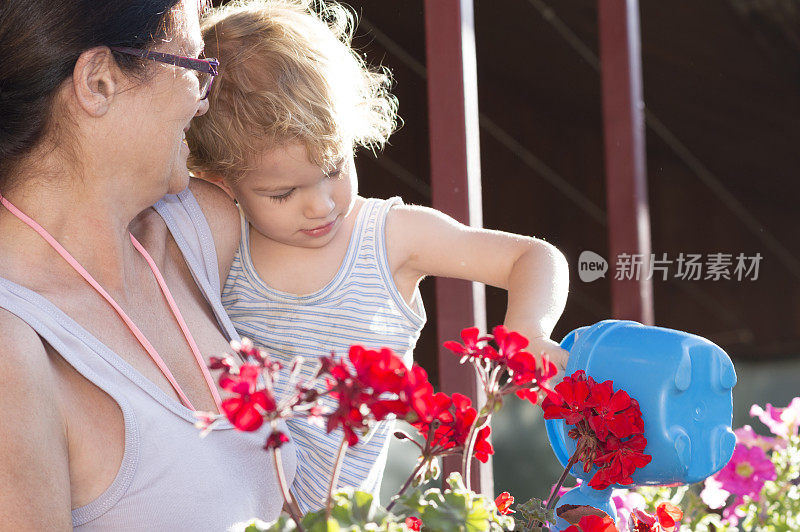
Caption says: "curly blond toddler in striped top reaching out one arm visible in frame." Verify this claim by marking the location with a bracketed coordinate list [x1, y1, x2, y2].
[187, 0, 568, 511]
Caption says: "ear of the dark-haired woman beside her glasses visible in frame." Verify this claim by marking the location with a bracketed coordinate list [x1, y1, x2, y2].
[72, 46, 121, 117]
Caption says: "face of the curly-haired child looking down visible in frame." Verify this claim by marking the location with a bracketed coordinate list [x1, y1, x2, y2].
[230, 143, 357, 248]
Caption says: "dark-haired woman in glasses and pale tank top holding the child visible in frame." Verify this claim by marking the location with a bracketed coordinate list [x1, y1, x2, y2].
[0, 0, 295, 530]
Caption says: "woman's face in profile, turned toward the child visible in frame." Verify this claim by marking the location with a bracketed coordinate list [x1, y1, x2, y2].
[117, 0, 208, 196]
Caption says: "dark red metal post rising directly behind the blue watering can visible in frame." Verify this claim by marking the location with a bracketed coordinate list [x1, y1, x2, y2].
[597, 0, 653, 324]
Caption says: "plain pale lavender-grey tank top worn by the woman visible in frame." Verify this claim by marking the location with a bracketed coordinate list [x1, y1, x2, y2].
[0, 190, 297, 531]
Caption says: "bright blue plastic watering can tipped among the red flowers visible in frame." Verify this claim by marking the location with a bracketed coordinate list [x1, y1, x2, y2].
[545, 320, 736, 530]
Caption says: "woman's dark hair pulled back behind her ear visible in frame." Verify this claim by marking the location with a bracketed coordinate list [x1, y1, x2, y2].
[0, 0, 184, 184]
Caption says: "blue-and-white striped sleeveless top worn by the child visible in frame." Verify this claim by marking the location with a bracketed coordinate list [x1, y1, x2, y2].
[222, 198, 426, 512]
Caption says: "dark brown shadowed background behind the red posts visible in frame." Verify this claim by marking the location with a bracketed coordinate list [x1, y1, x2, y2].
[349, 0, 800, 366]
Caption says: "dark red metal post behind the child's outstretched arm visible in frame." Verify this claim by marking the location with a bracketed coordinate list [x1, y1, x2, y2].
[425, 0, 493, 495]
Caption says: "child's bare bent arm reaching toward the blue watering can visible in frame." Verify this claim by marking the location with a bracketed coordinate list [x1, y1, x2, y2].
[386, 205, 569, 369]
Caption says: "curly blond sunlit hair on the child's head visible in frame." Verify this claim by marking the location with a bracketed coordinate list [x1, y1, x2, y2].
[187, 0, 397, 181]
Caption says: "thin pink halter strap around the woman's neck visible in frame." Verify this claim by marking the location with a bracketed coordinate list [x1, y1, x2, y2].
[0, 195, 222, 412]
